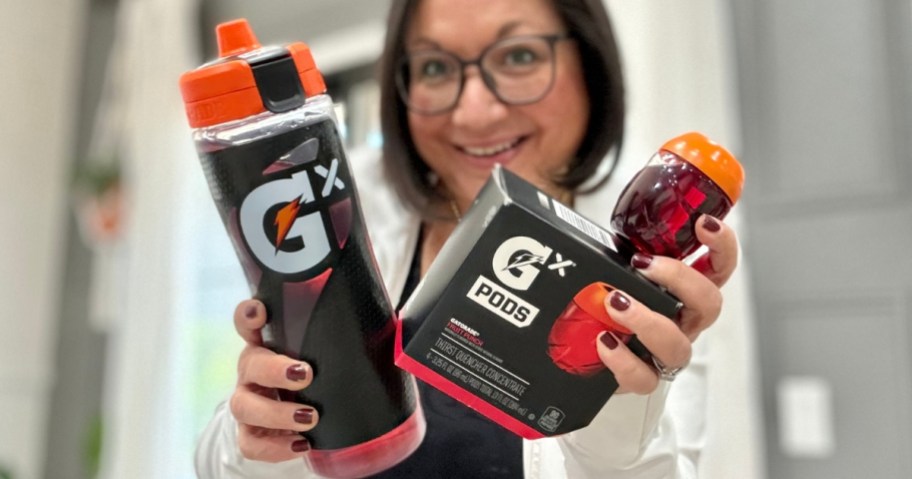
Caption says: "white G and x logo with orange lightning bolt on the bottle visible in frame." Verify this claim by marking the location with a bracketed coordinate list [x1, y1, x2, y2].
[240, 138, 351, 274]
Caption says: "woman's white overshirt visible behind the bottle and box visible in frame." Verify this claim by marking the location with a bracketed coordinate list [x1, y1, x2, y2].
[196, 151, 725, 479]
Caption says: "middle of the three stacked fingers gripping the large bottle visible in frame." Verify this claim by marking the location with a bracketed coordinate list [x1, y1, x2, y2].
[229, 387, 320, 432]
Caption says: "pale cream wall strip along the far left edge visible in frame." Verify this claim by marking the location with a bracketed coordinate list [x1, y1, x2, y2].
[0, 0, 84, 479]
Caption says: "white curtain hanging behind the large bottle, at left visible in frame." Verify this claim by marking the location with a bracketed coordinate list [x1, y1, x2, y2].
[101, 0, 201, 479]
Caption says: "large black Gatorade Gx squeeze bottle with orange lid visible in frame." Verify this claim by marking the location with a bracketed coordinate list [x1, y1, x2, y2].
[180, 20, 425, 478]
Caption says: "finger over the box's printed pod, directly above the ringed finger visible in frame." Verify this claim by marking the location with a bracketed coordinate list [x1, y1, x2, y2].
[605, 291, 692, 374]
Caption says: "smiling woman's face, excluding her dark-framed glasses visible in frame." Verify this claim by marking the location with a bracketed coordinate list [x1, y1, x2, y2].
[405, 0, 589, 209]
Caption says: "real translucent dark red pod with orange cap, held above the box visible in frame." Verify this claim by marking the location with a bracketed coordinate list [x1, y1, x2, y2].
[611, 132, 744, 258]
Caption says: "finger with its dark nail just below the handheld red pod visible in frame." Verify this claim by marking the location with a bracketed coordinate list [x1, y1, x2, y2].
[631, 253, 722, 340]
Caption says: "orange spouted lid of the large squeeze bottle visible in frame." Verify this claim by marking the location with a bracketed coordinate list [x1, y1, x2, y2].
[180, 19, 326, 128]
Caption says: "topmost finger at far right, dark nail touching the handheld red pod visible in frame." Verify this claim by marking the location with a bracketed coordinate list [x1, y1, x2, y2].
[692, 215, 738, 287]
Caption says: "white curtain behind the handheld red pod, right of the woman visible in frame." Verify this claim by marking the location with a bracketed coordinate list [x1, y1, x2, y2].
[605, 0, 765, 479]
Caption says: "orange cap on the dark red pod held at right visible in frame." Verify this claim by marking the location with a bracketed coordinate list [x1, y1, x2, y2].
[660, 131, 744, 204]
